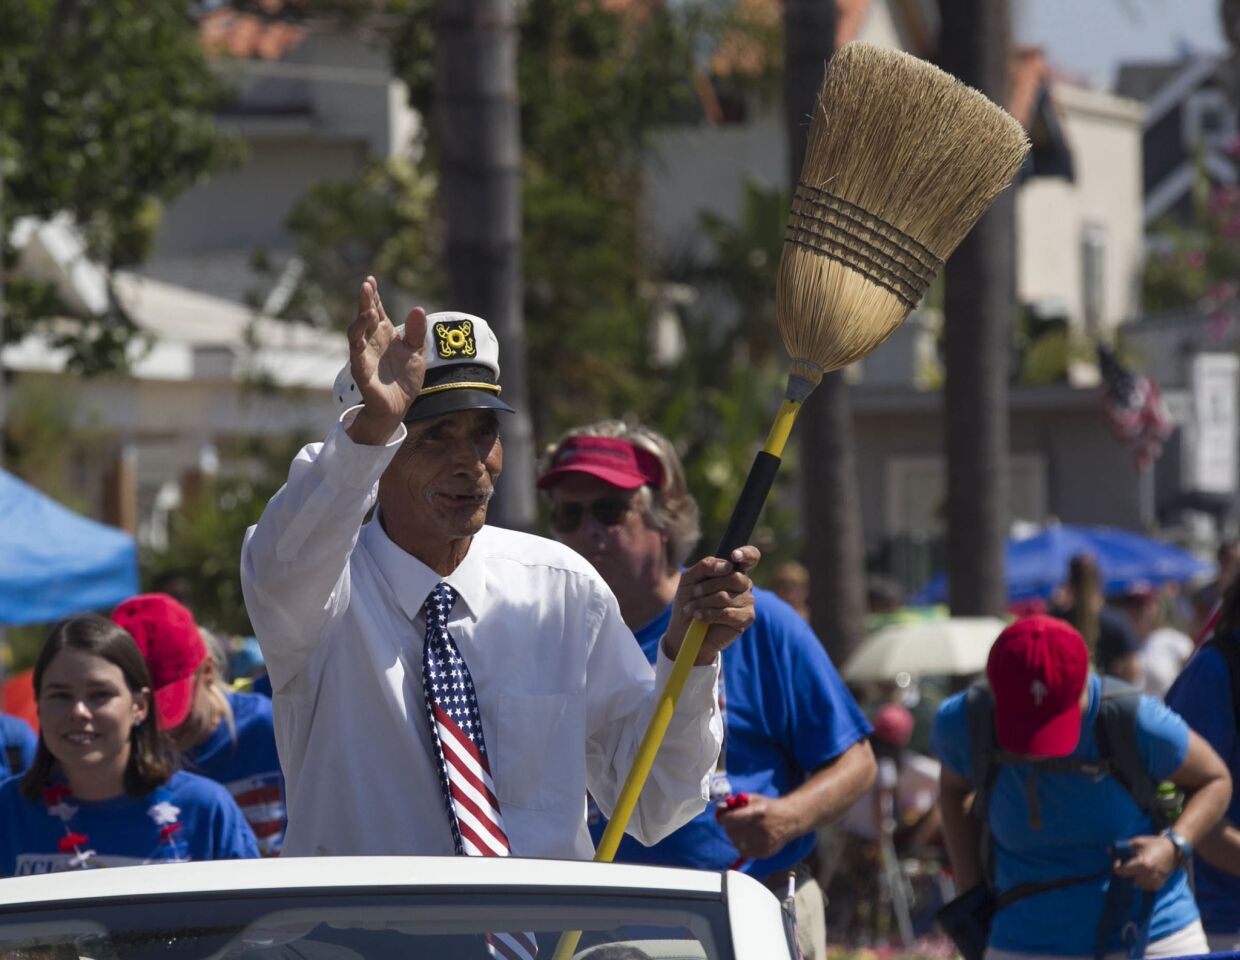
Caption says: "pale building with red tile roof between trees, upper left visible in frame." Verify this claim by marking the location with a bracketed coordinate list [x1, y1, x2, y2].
[140, 6, 419, 303]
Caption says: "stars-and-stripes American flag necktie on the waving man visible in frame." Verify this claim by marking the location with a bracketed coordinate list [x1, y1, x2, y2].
[422, 582, 538, 960]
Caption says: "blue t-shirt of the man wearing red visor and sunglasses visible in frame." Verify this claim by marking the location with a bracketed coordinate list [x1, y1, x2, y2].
[590, 588, 872, 877]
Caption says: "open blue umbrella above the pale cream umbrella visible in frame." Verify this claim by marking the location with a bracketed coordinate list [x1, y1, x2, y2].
[913, 525, 1213, 604]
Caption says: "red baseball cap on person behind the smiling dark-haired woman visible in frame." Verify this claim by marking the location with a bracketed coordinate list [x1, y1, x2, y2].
[112, 593, 207, 731]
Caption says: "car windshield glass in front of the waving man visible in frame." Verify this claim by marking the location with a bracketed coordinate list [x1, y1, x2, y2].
[0, 891, 733, 960]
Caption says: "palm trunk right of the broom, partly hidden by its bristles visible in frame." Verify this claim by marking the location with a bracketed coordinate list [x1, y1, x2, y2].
[939, 0, 1016, 615]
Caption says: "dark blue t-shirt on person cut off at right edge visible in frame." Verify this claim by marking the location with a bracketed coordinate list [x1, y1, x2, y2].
[1167, 647, 1240, 934]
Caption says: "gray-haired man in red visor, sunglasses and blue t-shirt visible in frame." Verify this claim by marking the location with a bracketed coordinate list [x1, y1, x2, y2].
[538, 420, 875, 959]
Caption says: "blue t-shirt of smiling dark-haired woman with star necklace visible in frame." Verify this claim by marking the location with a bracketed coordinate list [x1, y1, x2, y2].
[0, 770, 258, 877]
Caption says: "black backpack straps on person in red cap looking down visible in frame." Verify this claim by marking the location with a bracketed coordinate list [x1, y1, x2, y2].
[965, 677, 1169, 886]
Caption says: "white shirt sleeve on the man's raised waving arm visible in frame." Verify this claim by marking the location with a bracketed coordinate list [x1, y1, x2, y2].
[241, 407, 405, 690]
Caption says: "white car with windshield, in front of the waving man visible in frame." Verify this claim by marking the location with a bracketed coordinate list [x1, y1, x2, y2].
[0, 857, 796, 960]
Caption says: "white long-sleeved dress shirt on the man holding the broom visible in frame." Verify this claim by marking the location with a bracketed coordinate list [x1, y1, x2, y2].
[242, 408, 723, 860]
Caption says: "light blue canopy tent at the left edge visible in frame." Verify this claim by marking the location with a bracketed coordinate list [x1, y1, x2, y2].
[0, 470, 138, 626]
